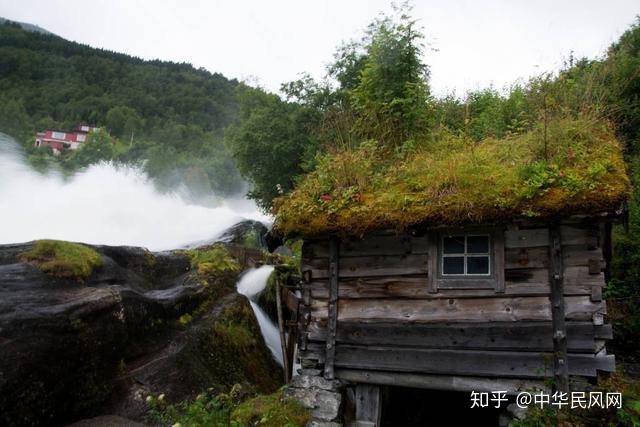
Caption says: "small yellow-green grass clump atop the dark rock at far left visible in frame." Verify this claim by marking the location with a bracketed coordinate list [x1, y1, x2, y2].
[18, 240, 102, 282]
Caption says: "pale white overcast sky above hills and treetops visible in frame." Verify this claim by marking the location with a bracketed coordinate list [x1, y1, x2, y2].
[0, 0, 640, 95]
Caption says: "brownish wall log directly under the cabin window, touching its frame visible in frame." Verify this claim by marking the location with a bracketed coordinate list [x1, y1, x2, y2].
[305, 276, 601, 300]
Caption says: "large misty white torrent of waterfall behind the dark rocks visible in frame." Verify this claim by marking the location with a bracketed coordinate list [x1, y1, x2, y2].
[0, 133, 268, 250]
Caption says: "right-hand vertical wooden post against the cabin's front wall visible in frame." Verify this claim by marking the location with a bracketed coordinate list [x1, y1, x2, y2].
[549, 224, 569, 392]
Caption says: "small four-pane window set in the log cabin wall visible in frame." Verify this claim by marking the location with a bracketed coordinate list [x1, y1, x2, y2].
[440, 234, 491, 276]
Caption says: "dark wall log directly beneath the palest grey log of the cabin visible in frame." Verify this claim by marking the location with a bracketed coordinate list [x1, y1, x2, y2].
[308, 322, 611, 354]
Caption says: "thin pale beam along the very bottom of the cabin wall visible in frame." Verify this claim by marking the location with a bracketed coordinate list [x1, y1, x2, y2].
[336, 369, 548, 394]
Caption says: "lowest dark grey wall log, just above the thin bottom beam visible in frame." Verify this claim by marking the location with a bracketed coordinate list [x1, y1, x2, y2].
[301, 344, 615, 378]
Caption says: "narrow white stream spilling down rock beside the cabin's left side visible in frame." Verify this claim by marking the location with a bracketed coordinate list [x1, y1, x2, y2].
[237, 265, 283, 366]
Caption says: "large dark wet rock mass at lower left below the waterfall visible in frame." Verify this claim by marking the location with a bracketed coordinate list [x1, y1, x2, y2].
[0, 243, 280, 426]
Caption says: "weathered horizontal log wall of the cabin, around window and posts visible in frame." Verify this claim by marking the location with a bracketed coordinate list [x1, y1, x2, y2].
[300, 224, 614, 378]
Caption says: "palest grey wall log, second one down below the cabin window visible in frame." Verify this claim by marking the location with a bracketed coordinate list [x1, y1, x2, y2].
[312, 296, 604, 322]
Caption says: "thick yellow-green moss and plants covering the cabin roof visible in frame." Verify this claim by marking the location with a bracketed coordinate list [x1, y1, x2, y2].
[275, 117, 630, 237]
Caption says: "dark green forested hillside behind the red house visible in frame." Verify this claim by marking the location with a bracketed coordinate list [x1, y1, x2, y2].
[0, 23, 242, 198]
